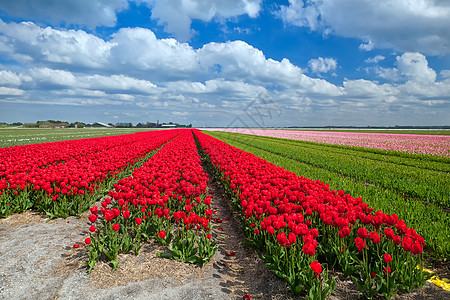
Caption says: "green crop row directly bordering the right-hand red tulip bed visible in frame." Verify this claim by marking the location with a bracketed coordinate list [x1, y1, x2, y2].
[207, 132, 450, 260]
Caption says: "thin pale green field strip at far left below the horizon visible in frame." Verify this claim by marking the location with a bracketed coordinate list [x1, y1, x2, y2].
[0, 128, 158, 148]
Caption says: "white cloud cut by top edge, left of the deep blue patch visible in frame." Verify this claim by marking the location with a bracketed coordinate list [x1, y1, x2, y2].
[144, 0, 262, 41]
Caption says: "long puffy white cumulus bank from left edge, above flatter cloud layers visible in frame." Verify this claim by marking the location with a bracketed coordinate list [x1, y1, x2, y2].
[0, 20, 302, 84]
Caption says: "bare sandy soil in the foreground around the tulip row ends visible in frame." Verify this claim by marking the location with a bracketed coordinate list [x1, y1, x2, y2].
[0, 172, 450, 300]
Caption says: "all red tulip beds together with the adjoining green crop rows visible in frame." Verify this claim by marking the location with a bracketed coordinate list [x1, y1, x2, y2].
[0, 129, 450, 299]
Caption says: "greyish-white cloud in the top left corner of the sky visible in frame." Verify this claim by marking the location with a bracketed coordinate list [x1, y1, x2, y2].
[1, 0, 128, 28]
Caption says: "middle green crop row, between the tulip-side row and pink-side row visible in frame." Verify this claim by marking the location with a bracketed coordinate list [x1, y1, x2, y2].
[209, 133, 450, 208]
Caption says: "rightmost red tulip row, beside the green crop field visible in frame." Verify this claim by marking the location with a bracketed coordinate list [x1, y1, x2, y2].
[196, 132, 428, 299]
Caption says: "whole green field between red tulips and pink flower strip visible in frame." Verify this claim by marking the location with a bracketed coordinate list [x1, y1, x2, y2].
[205, 132, 450, 260]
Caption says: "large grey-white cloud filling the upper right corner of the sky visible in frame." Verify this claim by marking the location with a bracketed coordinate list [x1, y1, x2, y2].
[278, 0, 450, 55]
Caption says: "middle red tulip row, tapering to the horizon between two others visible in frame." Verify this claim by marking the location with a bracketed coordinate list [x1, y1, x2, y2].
[86, 130, 217, 271]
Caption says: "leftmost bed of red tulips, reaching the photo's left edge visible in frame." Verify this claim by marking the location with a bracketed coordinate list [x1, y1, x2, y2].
[0, 130, 181, 217]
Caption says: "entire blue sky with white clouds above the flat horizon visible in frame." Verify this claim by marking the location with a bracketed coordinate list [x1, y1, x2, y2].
[0, 0, 450, 127]
